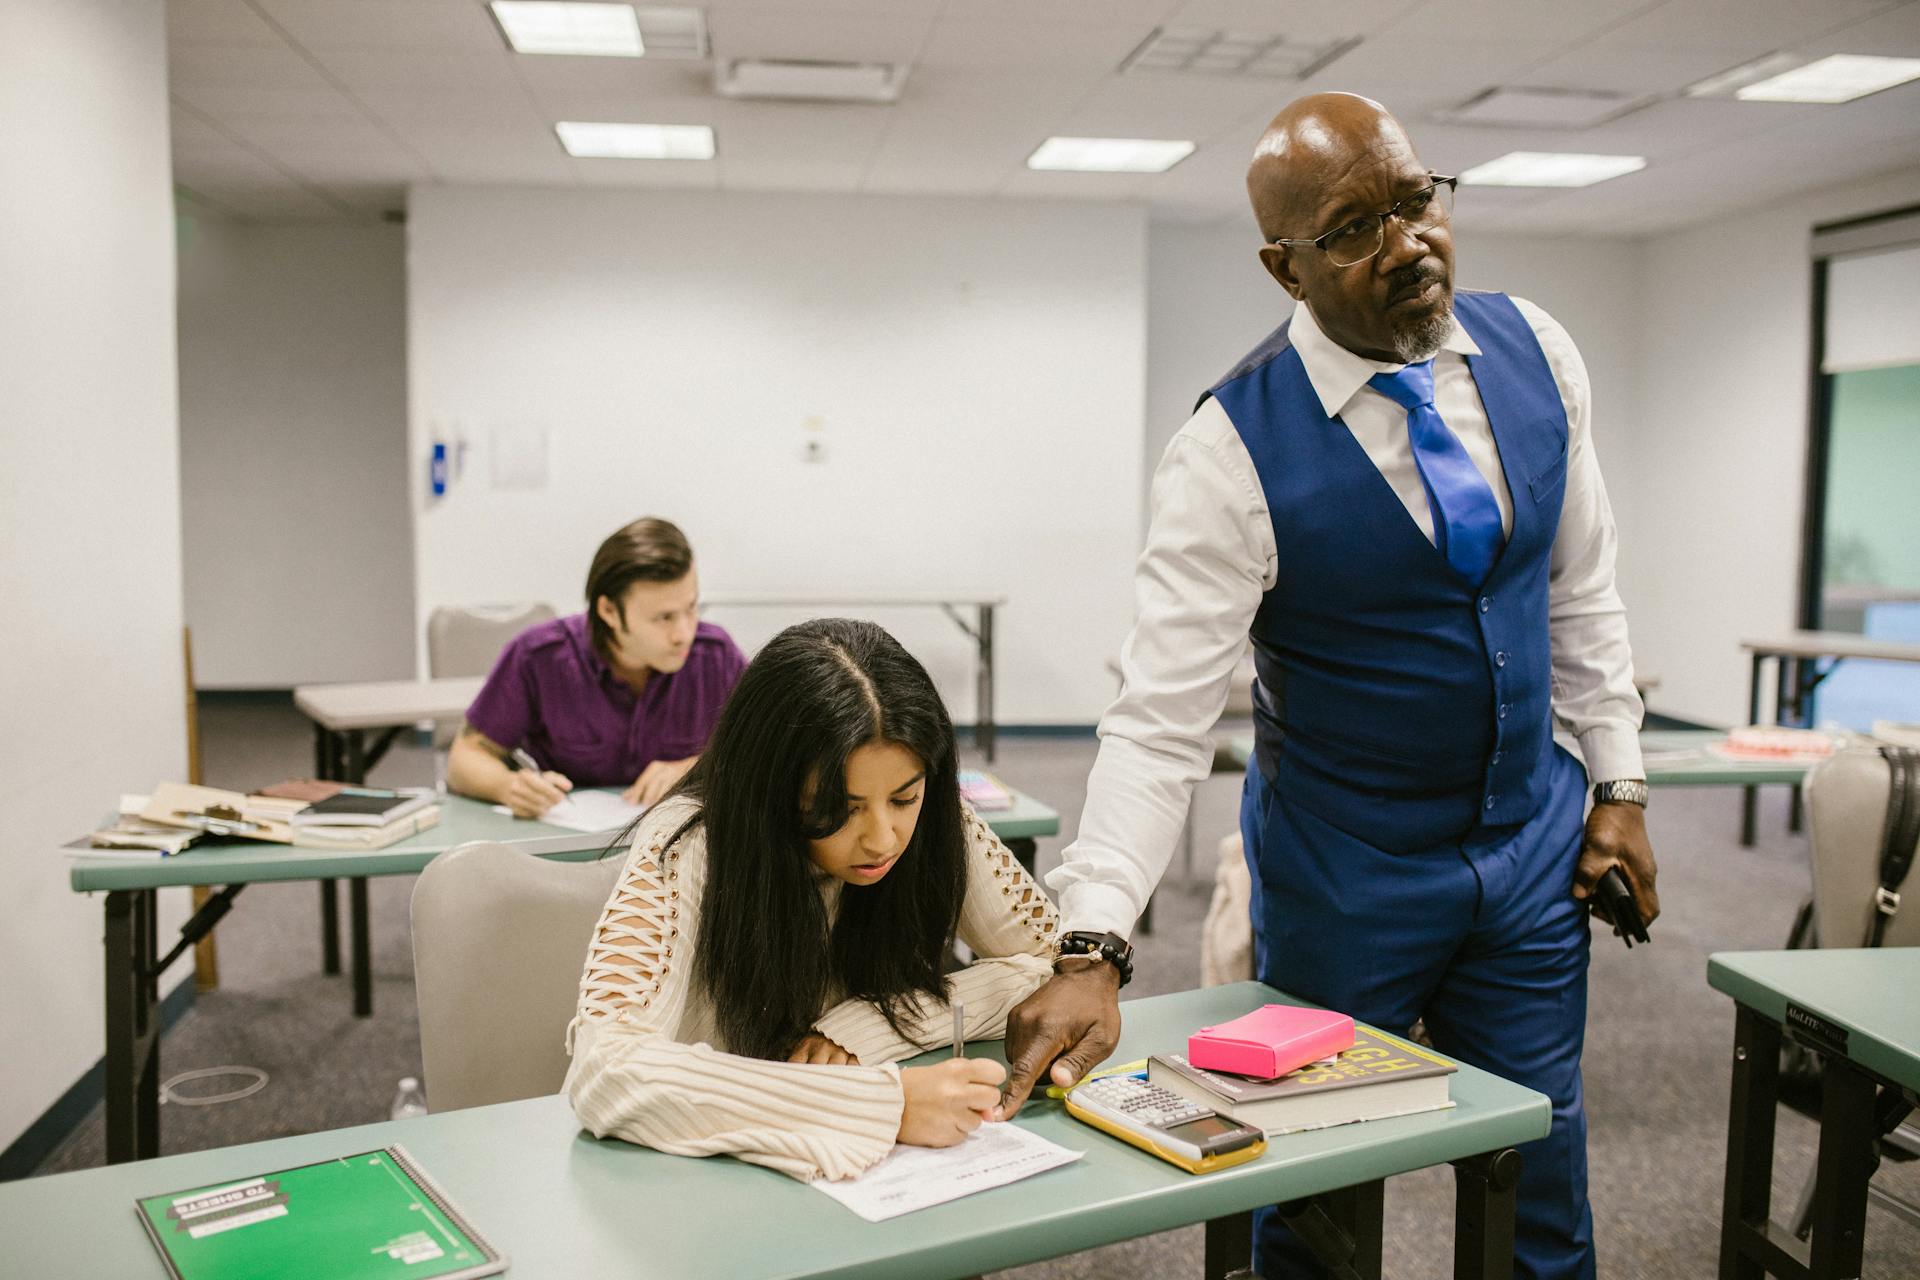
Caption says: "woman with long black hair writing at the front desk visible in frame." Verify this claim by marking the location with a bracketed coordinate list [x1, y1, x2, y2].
[566, 618, 1058, 1178]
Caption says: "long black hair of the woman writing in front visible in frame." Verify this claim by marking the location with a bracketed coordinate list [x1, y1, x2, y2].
[676, 618, 968, 1057]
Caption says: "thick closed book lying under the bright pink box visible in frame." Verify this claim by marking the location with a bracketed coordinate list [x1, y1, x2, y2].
[1146, 1027, 1459, 1138]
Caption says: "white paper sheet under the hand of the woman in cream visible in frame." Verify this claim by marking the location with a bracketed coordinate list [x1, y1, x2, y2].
[808, 1123, 1081, 1222]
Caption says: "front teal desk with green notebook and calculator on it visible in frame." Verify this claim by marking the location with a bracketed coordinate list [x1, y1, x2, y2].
[0, 983, 1549, 1280]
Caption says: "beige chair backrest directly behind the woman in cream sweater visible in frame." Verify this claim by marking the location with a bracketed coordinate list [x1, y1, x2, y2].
[411, 844, 626, 1111]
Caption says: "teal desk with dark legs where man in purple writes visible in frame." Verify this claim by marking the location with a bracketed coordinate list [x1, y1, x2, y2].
[69, 791, 1060, 1163]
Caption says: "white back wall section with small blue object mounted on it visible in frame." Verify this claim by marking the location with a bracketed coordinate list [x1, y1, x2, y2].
[407, 188, 1146, 723]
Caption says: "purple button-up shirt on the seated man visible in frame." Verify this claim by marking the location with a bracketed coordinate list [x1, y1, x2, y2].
[467, 614, 747, 787]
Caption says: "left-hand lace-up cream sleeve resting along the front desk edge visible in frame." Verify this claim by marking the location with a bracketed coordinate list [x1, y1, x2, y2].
[564, 806, 904, 1178]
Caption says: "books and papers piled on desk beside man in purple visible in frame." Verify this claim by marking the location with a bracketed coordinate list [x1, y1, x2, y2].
[90, 779, 440, 856]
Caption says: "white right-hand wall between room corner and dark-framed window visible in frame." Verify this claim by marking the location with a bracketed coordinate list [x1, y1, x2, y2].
[1622, 173, 1920, 723]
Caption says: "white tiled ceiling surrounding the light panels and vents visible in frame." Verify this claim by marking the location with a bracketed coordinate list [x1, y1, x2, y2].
[167, 0, 1920, 234]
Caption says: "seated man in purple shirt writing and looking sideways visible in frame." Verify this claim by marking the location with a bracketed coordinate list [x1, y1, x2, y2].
[447, 518, 747, 818]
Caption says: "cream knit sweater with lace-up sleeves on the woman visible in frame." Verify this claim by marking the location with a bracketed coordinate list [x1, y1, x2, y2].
[564, 798, 1060, 1178]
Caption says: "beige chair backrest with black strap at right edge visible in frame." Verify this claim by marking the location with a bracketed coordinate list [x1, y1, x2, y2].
[1805, 747, 1920, 946]
